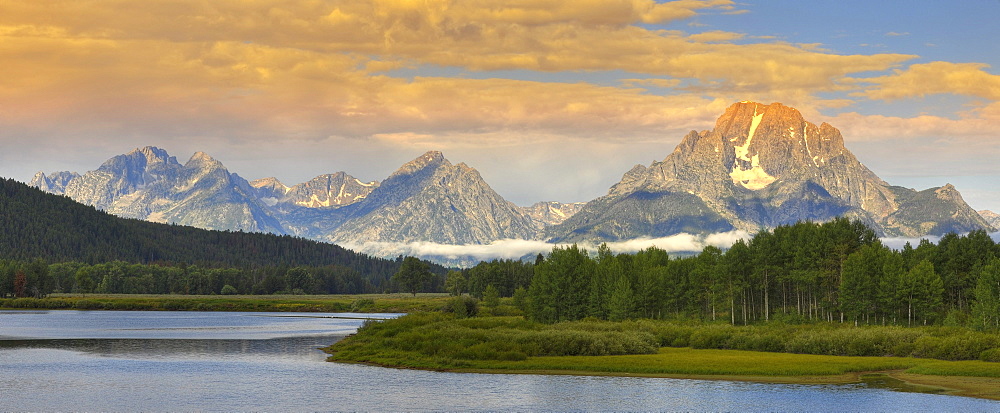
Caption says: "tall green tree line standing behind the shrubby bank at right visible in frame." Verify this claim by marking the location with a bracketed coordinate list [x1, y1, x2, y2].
[454, 219, 1000, 328]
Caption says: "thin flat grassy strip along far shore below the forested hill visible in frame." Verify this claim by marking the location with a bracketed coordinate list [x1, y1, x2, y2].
[0, 294, 447, 313]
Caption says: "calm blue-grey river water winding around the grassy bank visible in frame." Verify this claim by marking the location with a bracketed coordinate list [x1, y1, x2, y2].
[0, 311, 1000, 411]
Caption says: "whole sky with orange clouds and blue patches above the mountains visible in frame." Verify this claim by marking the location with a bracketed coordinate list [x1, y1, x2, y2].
[0, 0, 1000, 211]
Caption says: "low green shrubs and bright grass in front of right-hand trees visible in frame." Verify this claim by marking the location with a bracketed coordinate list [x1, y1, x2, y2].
[326, 313, 1000, 390]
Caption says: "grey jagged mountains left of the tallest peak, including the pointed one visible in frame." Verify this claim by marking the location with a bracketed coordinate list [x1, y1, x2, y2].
[30, 147, 548, 245]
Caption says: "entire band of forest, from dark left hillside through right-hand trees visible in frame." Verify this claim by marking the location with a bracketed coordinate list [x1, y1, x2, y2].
[7, 173, 1000, 329]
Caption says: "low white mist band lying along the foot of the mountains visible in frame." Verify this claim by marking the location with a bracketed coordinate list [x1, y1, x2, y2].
[344, 231, 750, 262]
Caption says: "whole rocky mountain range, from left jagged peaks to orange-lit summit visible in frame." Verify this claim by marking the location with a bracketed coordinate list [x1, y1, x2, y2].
[30, 102, 993, 254]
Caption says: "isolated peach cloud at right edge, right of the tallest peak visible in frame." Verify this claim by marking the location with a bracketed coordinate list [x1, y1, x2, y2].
[852, 62, 1000, 101]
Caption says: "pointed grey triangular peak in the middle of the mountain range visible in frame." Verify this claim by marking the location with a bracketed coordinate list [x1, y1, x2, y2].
[326, 151, 536, 244]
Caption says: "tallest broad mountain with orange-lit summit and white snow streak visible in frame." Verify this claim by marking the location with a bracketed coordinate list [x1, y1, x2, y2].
[546, 102, 989, 242]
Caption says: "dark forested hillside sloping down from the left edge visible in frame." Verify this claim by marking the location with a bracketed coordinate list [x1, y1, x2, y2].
[0, 179, 444, 296]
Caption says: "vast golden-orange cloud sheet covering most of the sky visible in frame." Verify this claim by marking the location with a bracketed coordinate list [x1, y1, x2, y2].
[0, 0, 960, 150]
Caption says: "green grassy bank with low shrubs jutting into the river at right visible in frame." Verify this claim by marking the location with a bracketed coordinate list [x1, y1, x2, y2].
[327, 313, 1000, 399]
